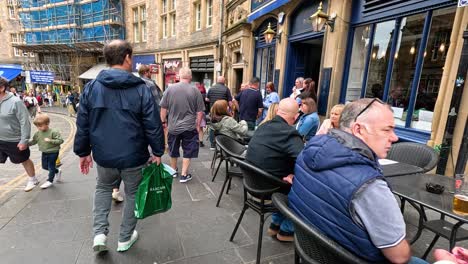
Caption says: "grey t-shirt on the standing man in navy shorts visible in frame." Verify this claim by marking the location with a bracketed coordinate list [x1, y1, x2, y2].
[161, 82, 205, 135]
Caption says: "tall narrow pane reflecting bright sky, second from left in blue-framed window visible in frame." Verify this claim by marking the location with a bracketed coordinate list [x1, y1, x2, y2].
[365, 20, 395, 98]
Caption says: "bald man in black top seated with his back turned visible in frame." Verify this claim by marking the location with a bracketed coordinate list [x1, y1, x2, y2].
[246, 98, 304, 242]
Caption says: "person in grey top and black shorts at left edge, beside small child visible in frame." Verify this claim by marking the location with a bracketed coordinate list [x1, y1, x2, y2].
[0, 77, 39, 192]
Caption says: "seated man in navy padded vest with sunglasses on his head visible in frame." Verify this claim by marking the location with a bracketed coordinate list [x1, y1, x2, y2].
[289, 98, 427, 263]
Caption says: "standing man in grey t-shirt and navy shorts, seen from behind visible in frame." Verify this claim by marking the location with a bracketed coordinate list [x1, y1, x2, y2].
[161, 68, 205, 182]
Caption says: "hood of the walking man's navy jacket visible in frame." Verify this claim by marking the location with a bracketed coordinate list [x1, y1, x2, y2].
[96, 68, 145, 89]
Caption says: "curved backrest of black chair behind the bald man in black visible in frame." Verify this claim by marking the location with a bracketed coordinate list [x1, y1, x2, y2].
[232, 158, 290, 200]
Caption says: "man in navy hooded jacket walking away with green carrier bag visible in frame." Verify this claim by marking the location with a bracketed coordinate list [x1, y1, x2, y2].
[74, 40, 164, 252]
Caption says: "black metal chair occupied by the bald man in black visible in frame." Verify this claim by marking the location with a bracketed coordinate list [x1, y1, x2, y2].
[229, 158, 290, 264]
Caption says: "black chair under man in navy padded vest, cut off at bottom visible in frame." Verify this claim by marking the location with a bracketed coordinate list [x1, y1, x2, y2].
[272, 193, 368, 264]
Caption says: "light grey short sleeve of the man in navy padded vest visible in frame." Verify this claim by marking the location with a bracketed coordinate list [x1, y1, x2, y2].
[351, 180, 406, 249]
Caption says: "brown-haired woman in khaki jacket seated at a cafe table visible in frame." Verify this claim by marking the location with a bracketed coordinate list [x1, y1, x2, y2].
[210, 100, 248, 141]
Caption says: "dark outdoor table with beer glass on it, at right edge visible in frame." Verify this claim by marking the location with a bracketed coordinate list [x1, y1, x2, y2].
[386, 174, 468, 258]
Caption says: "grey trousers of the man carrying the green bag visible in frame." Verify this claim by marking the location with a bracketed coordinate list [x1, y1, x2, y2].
[93, 165, 146, 242]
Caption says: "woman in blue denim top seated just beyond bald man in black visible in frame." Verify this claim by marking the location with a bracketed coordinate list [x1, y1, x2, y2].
[296, 97, 320, 142]
